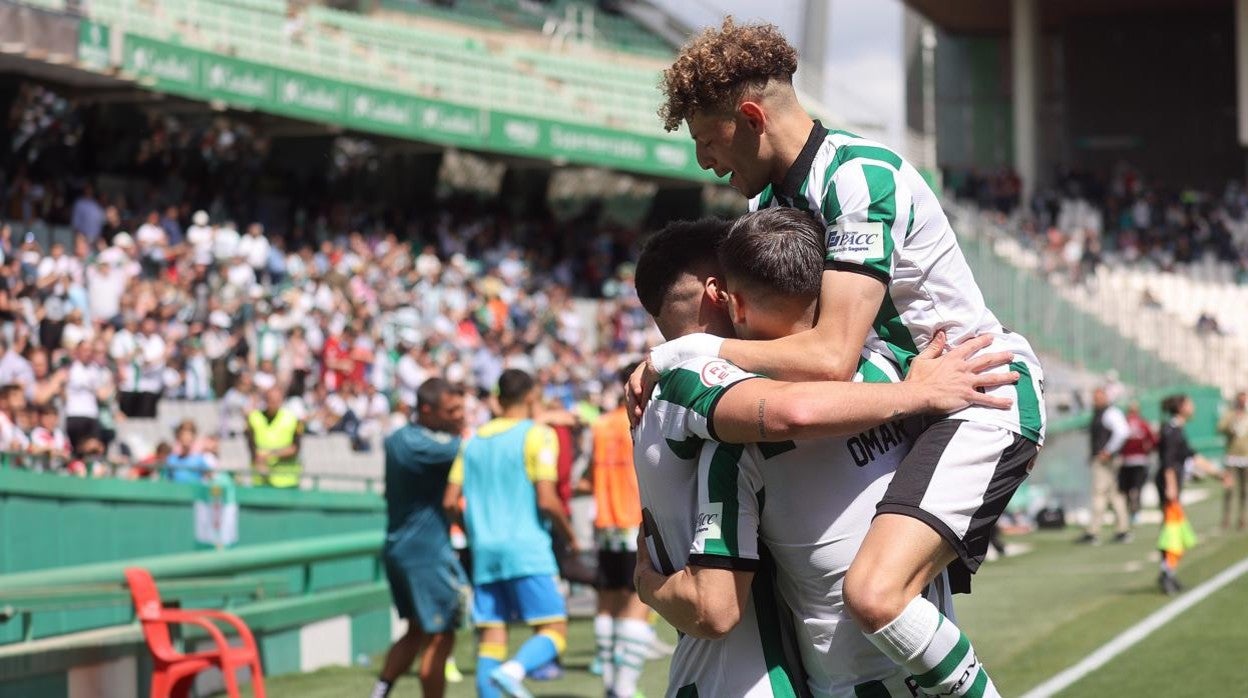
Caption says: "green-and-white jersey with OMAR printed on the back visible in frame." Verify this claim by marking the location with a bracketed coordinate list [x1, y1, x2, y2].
[689, 357, 947, 698]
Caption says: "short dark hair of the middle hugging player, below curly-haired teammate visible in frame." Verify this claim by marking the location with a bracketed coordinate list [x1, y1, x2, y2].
[719, 207, 825, 300]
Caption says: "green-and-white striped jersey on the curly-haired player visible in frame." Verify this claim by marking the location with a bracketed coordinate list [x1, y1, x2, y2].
[750, 121, 1045, 443]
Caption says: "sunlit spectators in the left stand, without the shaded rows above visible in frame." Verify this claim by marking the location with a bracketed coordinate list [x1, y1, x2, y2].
[0, 202, 653, 479]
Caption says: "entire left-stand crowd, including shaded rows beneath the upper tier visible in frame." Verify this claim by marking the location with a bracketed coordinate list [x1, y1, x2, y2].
[0, 84, 654, 474]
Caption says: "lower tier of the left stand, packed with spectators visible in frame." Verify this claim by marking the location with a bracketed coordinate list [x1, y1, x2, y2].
[0, 68, 653, 489]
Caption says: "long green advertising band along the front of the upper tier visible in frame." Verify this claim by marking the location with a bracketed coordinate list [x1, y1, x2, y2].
[106, 22, 715, 181]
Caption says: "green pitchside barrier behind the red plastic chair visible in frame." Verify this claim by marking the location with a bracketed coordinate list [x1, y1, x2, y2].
[0, 528, 393, 696]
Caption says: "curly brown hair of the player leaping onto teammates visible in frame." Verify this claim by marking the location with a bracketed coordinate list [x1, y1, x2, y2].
[659, 16, 797, 131]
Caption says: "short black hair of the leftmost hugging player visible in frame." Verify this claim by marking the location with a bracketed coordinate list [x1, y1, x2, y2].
[633, 219, 729, 317]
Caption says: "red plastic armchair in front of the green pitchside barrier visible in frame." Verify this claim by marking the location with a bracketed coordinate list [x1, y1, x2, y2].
[126, 567, 265, 698]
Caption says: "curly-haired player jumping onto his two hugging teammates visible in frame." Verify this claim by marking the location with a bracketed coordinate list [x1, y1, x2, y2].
[630, 19, 1045, 696]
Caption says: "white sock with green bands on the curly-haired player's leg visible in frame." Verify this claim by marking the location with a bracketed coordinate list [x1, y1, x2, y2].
[866, 597, 1001, 698]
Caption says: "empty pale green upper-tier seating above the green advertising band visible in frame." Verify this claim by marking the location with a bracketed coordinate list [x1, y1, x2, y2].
[80, 0, 661, 136]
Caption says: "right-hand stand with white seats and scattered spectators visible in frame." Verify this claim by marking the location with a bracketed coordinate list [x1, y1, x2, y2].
[955, 166, 1248, 396]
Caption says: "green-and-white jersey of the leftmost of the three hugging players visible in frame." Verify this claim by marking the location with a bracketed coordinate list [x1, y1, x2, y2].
[633, 358, 806, 698]
